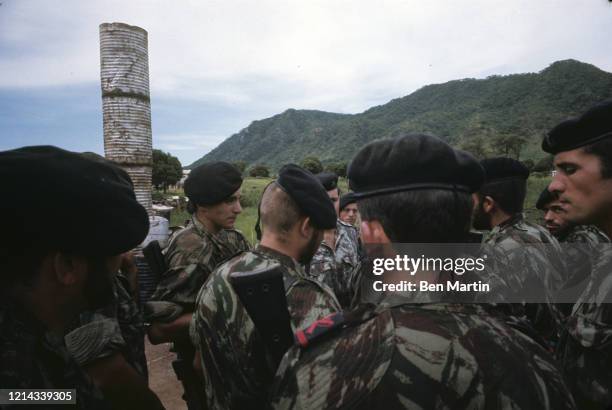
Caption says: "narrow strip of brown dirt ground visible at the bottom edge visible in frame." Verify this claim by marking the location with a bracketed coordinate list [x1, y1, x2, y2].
[145, 338, 187, 410]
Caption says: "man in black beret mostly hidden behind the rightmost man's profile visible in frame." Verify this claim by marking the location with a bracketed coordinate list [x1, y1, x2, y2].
[536, 187, 610, 294]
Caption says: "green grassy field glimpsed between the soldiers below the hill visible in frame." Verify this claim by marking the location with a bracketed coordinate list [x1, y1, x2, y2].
[155, 176, 550, 244]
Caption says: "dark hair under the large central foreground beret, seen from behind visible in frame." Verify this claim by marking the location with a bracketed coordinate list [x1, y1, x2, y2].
[357, 189, 472, 243]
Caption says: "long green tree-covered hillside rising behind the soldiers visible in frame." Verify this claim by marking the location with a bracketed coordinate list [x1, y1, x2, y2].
[188, 60, 612, 169]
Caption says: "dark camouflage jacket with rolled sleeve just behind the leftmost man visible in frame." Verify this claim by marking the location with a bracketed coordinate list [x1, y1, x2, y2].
[65, 274, 147, 378]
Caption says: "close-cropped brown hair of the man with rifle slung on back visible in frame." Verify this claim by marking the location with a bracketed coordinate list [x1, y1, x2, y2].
[260, 182, 304, 235]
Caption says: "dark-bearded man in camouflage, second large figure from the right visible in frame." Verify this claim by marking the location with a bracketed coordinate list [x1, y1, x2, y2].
[473, 158, 567, 344]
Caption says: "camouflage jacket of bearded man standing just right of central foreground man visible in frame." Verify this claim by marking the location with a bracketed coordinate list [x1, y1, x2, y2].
[483, 214, 567, 343]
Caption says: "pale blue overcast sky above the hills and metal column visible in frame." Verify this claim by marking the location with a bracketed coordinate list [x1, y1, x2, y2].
[0, 0, 612, 165]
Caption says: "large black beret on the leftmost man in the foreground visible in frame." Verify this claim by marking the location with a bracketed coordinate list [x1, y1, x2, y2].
[0, 146, 149, 256]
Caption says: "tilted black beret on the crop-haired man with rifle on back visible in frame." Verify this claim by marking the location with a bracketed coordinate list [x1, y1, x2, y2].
[276, 164, 337, 229]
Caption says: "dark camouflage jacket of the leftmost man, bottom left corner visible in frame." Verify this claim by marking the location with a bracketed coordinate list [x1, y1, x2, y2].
[0, 300, 110, 410]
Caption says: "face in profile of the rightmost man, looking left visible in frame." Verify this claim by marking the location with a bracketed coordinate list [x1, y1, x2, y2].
[548, 148, 612, 223]
